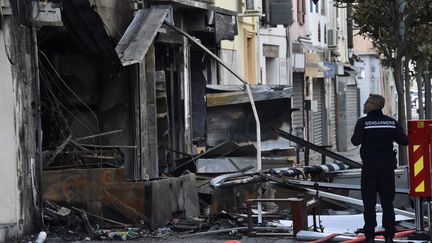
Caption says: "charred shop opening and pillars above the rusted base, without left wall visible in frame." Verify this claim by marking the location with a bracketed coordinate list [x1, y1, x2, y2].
[38, 1, 234, 179]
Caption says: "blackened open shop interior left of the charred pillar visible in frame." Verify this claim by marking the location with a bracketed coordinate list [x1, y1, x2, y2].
[37, 1, 135, 177]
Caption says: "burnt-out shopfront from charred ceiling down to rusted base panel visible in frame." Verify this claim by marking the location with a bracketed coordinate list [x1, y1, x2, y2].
[33, 0, 236, 237]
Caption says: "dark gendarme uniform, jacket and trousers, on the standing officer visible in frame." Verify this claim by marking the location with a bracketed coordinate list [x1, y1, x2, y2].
[351, 110, 408, 238]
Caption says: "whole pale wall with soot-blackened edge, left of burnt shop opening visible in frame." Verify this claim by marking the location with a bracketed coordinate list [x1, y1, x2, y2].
[0, 0, 39, 241]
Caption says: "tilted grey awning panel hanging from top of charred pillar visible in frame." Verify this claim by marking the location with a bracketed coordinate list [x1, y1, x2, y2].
[115, 8, 168, 66]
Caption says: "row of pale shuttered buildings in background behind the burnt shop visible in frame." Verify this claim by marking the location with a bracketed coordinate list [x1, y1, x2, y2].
[216, 0, 359, 156]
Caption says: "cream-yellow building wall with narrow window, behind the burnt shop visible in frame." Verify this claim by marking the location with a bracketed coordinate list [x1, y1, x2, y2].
[215, 0, 257, 84]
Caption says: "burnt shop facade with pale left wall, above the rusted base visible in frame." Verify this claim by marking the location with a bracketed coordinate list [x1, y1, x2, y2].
[0, 0, 236, 240]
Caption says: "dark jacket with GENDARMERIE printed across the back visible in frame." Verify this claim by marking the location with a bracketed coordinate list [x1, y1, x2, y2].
[351, 110, 408, 166]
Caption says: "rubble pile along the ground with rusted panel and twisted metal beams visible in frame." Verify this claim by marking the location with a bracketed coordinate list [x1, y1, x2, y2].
[42, 132, 416, 240]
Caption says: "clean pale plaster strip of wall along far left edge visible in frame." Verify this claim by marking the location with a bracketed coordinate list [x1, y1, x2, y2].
[0, 29, 19, 224]
